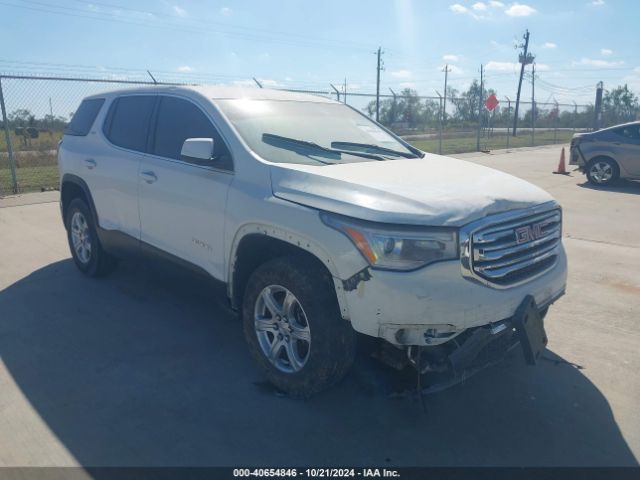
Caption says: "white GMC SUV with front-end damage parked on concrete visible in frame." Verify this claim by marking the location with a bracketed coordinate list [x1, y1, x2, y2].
[59, 87, 567, 396]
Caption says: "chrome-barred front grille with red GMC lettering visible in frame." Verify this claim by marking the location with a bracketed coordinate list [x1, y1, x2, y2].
[470, 209, 562, 286]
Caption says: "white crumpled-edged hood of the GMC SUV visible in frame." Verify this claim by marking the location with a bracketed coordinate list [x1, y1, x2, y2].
[271, 154, 553, 226]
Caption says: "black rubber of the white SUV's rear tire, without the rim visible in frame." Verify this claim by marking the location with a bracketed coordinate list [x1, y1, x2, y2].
[65, 198, 117, 277]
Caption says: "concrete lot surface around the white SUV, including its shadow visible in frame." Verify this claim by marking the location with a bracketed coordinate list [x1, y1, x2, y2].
[0, 147, 640, 466]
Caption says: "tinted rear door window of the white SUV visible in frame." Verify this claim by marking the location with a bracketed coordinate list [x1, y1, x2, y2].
[104, 95, 157, 152]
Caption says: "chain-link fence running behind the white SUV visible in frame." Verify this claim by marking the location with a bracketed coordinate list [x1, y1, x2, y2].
[0, 75, 594, 196]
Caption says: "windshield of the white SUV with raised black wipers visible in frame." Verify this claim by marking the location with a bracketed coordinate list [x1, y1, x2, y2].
[218, 99, 417, 165]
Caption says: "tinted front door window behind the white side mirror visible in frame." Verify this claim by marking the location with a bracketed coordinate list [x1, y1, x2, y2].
[151, 97, 232, 170]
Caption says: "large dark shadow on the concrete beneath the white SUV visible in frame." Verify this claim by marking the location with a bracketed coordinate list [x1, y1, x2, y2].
[0, 260, 637, 466]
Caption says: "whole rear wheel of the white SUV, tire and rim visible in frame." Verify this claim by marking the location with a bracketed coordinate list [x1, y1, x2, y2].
[65, 198, 116, 277]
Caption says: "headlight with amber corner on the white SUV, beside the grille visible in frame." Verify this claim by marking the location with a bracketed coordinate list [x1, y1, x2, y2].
[321, 213, 458, 270]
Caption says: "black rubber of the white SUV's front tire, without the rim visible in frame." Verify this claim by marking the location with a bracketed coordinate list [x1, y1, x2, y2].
[242, 256, 356, 398]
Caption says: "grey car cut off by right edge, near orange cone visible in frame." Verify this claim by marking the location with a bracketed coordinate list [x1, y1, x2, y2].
[569, 122, 640, 185]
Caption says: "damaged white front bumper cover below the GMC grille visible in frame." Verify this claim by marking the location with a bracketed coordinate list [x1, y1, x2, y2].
[344, 245, 567, 347]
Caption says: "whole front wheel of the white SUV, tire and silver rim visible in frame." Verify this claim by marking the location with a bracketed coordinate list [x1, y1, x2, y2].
[242, 257, 356, 398]
